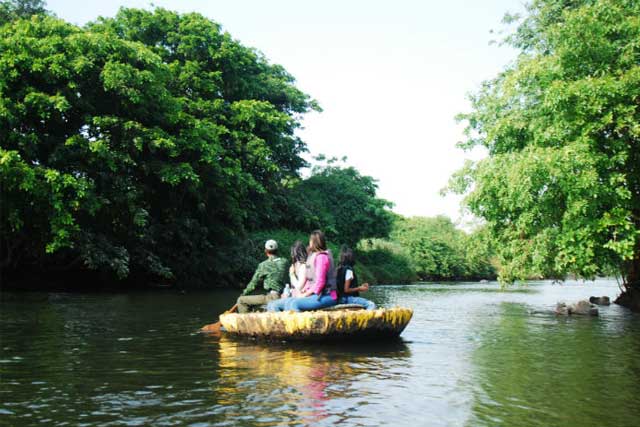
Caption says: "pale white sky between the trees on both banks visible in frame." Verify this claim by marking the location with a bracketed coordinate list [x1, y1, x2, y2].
[47, 0, 524, 223]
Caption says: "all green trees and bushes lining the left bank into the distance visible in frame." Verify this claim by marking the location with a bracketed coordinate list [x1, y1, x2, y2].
[0, 1, 493, 286]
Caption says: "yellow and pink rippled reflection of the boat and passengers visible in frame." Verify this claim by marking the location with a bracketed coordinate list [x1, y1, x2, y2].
[214, 337, 409, 425]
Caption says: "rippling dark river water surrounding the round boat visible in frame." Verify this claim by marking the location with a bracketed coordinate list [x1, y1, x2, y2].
[0, 280, 640, 427]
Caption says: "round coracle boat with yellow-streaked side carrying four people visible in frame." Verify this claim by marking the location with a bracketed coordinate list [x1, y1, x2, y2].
[220, 305, 413, 341]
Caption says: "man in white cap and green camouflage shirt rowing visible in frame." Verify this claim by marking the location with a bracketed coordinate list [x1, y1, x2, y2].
[237, 240, 289, 313]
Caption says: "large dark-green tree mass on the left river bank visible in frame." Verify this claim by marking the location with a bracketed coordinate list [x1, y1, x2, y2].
[0, 9, 317, 286]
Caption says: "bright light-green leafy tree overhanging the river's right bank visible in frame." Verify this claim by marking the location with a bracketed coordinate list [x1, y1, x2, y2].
[450, 0, 640, 308]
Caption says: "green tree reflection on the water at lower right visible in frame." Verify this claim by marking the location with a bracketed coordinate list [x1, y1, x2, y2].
[470, 304, 640, 426]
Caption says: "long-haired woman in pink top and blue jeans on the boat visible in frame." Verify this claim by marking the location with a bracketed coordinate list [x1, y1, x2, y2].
[285, 230, 338, 311]
